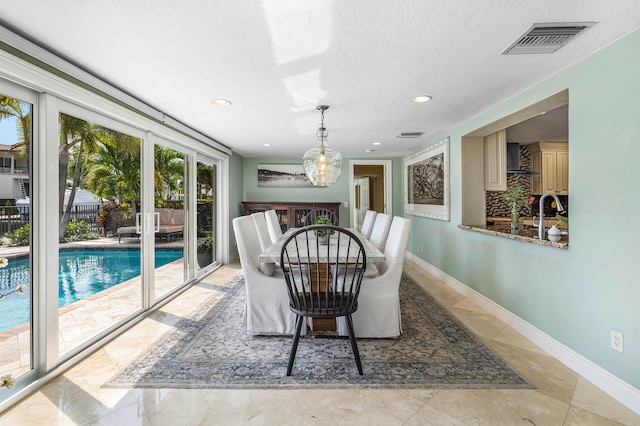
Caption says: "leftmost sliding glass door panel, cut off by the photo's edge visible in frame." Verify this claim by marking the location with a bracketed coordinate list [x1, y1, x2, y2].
[0, 80, 37, 380]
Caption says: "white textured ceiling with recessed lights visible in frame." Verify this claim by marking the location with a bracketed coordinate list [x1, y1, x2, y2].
[0, 0, 640, 158]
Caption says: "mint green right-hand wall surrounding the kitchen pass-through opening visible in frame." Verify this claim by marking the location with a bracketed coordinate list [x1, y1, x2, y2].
[407, 31, 640, 388]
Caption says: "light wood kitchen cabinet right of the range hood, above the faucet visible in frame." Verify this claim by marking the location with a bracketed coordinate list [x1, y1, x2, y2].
[529, 142, 569, 195]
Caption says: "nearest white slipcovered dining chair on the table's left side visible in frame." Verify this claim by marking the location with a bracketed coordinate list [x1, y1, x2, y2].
[233, 216, 298, 335]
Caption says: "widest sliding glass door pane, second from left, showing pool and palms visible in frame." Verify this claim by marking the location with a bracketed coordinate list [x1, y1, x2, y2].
[57, 112, 145, 354]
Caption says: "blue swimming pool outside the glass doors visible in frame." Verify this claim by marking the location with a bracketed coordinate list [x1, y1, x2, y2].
[0, 249, 183, 331]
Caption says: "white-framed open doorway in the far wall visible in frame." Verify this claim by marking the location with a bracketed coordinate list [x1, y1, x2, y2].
[349, 160, 392, 229]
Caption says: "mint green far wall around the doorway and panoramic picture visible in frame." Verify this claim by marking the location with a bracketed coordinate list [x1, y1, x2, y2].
[241, 158, 402, 226]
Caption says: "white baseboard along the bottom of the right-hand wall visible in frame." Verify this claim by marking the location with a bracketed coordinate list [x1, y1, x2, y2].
[406, 252, 640, 414]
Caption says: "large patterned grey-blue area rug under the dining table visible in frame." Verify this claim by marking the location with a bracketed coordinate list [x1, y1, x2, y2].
[103, 276, 532, 389]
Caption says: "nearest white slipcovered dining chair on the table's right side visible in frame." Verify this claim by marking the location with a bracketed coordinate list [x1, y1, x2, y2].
[337, 217, 411, 338]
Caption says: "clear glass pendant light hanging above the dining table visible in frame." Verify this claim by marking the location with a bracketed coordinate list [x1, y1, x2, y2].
[302, 105, 342, 186]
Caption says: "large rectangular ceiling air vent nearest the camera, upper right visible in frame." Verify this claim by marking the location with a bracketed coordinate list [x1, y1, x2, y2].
[502, 22, 595, 55]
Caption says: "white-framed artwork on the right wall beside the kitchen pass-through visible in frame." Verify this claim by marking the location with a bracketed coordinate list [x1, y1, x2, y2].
[404, 137, 449, 220]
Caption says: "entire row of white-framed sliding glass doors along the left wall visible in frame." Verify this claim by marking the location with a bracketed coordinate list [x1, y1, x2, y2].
[0, 68, 228, 407]
